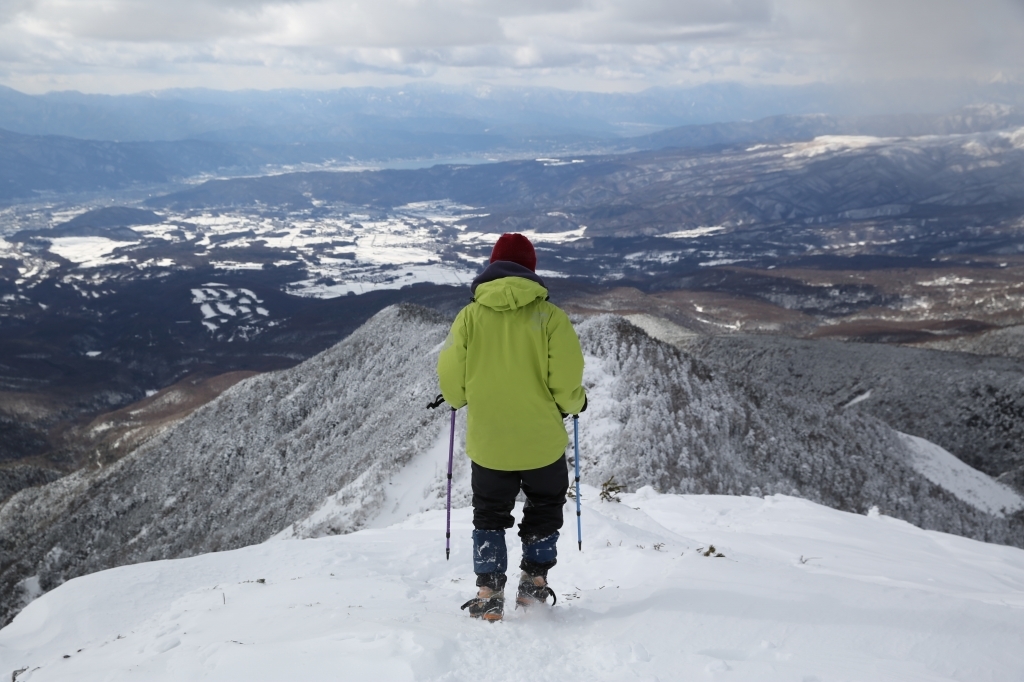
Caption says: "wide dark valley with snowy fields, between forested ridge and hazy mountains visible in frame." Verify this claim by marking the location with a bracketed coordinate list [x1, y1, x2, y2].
[0, 127, 1024, 473]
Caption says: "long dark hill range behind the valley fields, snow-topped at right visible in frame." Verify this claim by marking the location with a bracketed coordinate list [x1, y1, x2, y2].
[146, 122, 1024, 248]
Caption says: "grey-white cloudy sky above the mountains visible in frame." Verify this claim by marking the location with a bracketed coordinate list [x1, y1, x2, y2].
[0, 0, 1024, 93]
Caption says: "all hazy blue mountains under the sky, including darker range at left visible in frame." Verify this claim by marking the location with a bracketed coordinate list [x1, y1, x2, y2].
[6, 78, 1024, 203]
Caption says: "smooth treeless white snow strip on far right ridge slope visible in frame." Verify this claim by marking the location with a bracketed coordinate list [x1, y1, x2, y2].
[899, 433, 1024, 516]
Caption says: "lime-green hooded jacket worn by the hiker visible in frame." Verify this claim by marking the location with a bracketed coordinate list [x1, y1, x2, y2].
[437, 270, 586, 471]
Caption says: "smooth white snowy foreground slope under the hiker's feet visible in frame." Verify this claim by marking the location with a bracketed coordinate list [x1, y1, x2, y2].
[0, 486, 1024, 682]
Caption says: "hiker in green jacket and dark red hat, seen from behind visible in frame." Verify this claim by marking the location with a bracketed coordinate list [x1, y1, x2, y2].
[437, 233, 587, 621]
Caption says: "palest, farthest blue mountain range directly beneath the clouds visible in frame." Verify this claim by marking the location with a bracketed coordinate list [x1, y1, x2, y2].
[0, 84, 884, 140]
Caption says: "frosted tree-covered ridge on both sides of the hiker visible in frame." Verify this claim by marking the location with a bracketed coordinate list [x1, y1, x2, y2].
[0, 306, 1024, 622]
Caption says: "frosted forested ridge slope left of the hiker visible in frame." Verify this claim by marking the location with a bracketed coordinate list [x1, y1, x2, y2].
[0, 308, 446, 621]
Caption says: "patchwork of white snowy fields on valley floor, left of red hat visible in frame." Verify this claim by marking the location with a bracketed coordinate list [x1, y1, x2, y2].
[0, 202, 497, 298]
